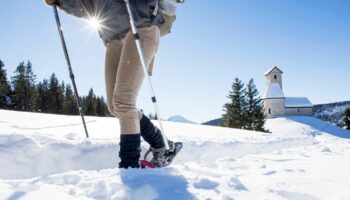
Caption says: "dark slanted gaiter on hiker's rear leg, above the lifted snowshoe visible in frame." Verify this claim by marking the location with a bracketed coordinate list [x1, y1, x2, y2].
[140, 115, 165, 149]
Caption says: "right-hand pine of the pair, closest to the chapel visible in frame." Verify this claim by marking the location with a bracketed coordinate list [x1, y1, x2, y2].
[244, 79, 266, 132]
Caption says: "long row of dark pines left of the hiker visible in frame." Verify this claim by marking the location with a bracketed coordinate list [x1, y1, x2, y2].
[0, 60, 109, 116]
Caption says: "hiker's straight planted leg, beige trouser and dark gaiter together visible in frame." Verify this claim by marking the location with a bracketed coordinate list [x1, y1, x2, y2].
[112, 26, 159, 168]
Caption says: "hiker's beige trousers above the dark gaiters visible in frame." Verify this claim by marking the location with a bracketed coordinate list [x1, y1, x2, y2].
[105, 26, 160, 134]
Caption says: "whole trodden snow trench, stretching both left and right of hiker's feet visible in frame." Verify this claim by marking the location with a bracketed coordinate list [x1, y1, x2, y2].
[0, 134, 316, 179]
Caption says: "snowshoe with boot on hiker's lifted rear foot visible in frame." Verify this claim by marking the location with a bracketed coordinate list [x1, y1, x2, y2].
[140, 141, 182, 168]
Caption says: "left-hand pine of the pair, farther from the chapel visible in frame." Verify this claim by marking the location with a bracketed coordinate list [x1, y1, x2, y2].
[223, 78, 246, 128]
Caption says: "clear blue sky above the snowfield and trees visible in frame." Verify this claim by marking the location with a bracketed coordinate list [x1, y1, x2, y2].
[0, 0, 350, 122]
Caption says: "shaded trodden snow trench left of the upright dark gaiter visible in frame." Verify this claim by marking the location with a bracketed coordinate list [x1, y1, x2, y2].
[0, 135, 117, 179]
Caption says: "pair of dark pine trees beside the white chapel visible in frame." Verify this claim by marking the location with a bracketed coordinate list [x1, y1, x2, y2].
[223, 78, 268, 132]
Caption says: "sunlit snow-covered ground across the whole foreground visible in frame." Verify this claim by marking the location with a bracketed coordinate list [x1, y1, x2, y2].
[0, 110, 350, 200]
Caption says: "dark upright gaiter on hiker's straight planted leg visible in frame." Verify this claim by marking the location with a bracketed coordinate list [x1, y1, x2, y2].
[119, 134, 141, 169]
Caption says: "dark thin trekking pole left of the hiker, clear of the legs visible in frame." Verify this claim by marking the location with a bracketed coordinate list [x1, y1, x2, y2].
[53, 6, 89, 138]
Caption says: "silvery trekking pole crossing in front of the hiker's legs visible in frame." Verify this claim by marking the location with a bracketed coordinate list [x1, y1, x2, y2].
[124, 0, 170, 150]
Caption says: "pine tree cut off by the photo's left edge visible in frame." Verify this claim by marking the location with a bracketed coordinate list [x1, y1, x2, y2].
[0, 60, 11, 108]
